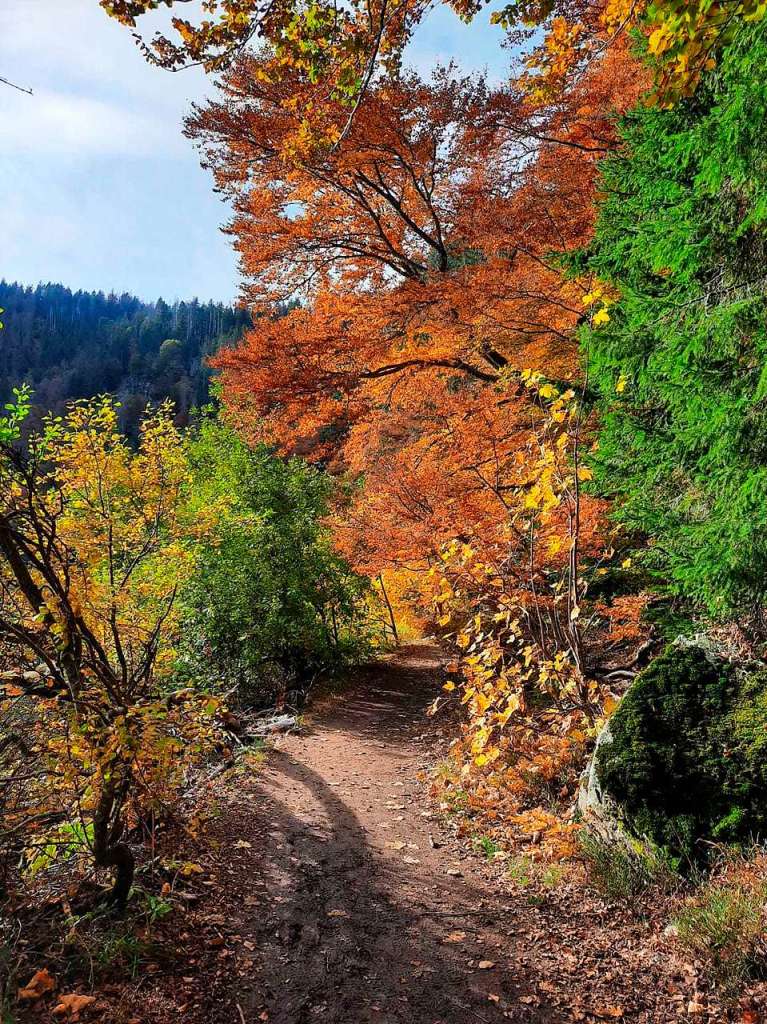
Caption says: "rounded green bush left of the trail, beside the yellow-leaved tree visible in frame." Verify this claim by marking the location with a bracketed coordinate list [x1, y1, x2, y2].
[181, 420, 369, 703]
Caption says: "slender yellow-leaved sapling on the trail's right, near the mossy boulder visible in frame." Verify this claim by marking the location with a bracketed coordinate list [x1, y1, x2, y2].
[430, 374, 644, 857]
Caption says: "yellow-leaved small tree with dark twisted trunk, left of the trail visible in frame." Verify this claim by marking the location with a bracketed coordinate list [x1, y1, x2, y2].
[0, 390, 218, 905]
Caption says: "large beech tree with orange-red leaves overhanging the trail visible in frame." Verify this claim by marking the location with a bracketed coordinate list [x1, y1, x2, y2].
[181, 45, 646, 845]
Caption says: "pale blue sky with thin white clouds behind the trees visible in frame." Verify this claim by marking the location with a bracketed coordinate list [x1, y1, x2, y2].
[0, 0, 508, 302]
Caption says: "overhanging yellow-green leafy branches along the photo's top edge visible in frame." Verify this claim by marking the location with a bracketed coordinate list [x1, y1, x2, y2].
[99, 0, 767, 117]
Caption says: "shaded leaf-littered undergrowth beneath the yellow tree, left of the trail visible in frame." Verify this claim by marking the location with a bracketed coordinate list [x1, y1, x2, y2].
[0, 741, 266, 1024]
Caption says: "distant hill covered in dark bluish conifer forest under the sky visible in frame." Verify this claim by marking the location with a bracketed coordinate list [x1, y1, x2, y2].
[0, 281, 251, 434]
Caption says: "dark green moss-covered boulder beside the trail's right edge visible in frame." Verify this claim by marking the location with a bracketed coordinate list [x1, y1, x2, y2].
[591, 642, 767, 863]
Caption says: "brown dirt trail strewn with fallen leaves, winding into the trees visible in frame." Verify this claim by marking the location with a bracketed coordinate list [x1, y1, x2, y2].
[144, 647, 723, 1024]
